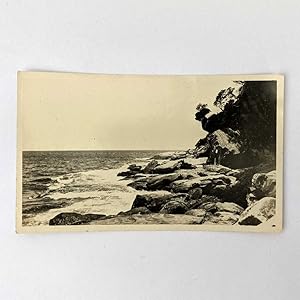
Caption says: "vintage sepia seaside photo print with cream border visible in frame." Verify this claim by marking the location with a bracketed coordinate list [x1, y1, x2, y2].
[16, 72, 283, 232]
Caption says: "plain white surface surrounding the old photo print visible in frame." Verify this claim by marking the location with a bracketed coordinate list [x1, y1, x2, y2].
[0, 0, 300, 300]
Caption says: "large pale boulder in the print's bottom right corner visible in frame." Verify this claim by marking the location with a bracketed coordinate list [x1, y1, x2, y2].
[238, 197, 276, 225]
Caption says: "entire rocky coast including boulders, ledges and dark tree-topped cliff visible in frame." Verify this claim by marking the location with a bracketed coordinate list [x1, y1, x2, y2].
[49, 81, 276, 226]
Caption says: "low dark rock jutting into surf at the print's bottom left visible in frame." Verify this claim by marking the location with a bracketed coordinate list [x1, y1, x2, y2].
[49, 213, 106, 225]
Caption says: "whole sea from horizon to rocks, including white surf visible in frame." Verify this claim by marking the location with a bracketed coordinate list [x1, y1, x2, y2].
[22, 151, 166, 225]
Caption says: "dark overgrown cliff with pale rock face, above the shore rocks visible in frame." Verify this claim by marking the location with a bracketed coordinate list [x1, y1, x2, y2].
[195, 81, 277, 168]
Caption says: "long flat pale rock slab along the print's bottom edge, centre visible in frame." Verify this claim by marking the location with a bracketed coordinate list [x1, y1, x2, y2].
[90, 213, 202, 225]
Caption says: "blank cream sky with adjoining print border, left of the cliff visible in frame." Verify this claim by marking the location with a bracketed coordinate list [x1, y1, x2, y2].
[19, 73, 238, 150]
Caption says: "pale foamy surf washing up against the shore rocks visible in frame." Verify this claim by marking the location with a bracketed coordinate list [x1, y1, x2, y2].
[22, 154, 180, 226]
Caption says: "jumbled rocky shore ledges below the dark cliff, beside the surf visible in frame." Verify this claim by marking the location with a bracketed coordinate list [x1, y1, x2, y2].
[49, 151, 276, 226]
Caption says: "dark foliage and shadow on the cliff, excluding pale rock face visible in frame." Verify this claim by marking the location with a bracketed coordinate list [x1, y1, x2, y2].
[196, 81, 276, 168]
